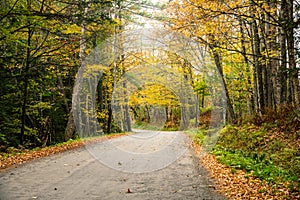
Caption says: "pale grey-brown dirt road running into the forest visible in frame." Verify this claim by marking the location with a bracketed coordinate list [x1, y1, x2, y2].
[0, 131, 225, 200]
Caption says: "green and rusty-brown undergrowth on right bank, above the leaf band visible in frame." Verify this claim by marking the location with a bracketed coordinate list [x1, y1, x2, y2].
[212, 107, 300, 193]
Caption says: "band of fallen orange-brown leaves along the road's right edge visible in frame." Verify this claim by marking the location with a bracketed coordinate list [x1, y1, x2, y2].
[193, 143, 300, 200]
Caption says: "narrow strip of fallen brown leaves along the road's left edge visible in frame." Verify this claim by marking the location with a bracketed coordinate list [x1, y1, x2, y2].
[0, 134, 127, 172]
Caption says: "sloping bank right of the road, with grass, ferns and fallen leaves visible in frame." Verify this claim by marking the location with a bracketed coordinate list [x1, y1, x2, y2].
[188, 107, 300, 200]
